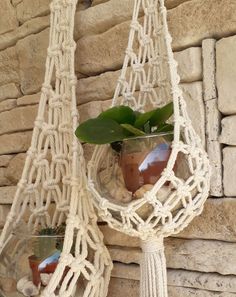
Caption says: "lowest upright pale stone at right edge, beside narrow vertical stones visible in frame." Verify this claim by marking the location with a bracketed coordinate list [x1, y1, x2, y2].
[223, 147, 236, 196]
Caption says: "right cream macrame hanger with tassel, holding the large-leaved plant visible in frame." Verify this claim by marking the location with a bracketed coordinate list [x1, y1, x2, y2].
[88, 0, 210, 297]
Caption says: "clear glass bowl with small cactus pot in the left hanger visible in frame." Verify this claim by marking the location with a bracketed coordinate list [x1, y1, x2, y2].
[0, 225, 66, 297]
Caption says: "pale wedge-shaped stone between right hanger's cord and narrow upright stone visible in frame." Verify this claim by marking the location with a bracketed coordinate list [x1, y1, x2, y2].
[181, 82, 205, 145]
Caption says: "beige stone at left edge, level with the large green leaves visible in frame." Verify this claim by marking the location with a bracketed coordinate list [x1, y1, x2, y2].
[0, 105, 38, 135]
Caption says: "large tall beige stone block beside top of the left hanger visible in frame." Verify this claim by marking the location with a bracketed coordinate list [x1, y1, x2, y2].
[16, 29, 49, 95]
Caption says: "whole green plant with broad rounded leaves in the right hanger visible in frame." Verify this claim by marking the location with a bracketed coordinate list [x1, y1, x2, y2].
[75, 102, 173, 150]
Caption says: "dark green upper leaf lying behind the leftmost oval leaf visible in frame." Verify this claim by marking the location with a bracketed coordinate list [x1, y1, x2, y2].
[98, 105, 136, 124]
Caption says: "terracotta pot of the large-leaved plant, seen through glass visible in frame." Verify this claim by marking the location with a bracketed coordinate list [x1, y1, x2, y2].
[120, 132, 173, 193]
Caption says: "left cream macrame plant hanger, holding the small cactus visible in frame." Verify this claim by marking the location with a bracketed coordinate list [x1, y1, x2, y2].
[0, 0, 112, 297]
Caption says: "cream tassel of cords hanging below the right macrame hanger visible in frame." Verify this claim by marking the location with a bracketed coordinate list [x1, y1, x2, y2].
[140, 238, 168, 297]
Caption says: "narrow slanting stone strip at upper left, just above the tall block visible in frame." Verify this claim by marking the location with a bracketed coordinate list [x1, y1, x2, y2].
[0, 16, 49, 50]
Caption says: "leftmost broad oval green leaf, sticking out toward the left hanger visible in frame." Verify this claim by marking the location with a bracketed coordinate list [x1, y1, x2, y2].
[75, 118, 127, 144]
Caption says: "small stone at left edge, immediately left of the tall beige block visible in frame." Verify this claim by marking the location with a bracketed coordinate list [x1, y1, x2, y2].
[0, 47, 20, 85]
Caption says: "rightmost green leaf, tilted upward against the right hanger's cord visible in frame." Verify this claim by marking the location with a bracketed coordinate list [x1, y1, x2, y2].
[150, 102, 174, 127]
